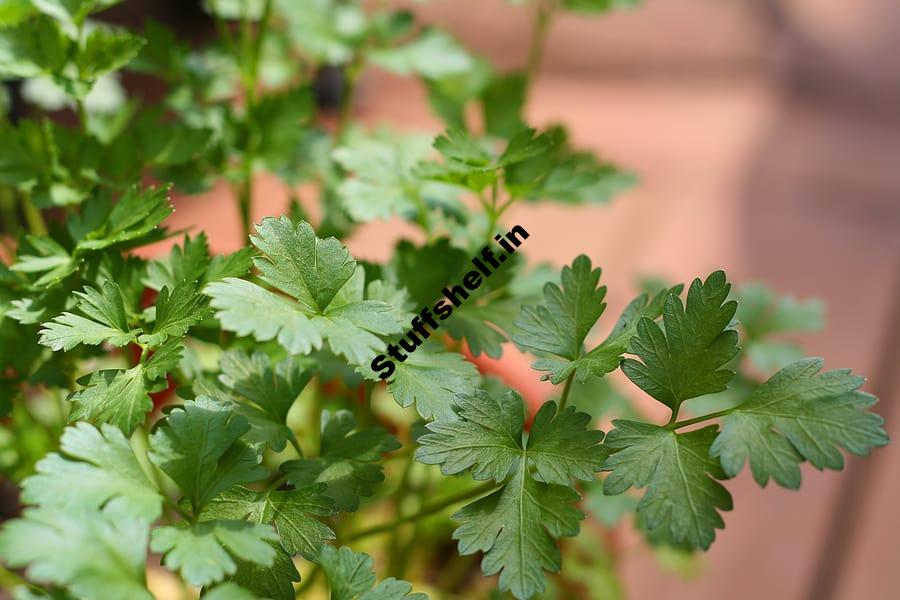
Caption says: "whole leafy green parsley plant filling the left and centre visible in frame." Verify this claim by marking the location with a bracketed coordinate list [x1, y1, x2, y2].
[0, 0, 887, 600]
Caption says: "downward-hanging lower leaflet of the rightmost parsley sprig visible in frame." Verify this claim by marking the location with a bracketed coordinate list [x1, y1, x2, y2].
[603, 419, 732, 549]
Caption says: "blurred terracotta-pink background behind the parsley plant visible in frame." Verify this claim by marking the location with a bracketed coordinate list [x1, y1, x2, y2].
[8, 0, 900, 600]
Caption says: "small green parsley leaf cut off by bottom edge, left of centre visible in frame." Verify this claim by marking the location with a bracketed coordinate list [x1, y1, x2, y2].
[319, 546, 428, 600]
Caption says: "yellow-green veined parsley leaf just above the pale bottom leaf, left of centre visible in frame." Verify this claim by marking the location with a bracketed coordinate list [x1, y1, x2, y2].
[200, 484, 335, 560]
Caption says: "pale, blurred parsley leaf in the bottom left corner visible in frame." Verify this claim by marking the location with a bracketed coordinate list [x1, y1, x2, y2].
[0, 508, 153, 600]
